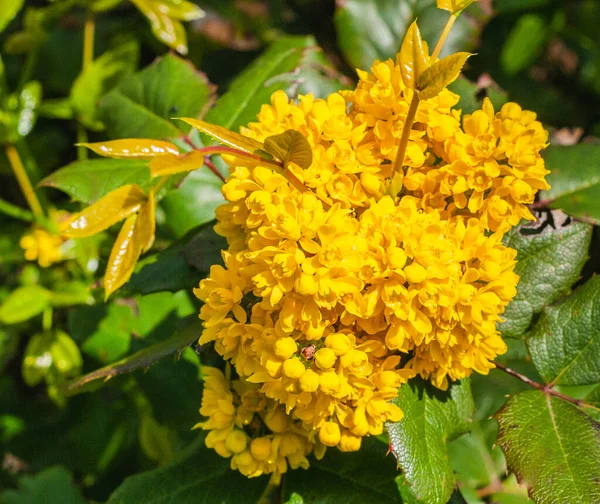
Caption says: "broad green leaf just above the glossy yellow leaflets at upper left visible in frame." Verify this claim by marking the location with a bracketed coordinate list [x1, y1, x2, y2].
[98, 54, 214, 138]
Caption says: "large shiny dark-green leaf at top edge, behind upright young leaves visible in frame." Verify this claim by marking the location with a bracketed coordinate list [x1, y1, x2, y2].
[334, 0, 478, 70]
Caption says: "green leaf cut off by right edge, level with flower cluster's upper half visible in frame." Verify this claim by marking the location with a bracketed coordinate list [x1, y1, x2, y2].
[540, 144, 600, 223]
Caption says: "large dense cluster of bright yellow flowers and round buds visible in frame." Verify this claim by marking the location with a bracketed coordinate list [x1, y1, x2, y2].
[195, 53, 548, 476]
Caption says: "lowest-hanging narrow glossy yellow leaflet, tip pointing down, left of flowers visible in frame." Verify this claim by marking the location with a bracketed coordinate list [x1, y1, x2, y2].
[104, 214, 142, 299]
